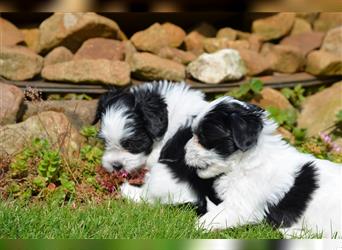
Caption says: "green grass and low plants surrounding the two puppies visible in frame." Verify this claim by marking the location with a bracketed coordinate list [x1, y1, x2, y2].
[0, 79, 342, 239]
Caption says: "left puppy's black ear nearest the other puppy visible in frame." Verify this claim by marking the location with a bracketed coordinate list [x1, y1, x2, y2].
[136, 92, 168, 138]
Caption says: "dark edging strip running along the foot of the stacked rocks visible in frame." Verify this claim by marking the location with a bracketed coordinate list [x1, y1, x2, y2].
[0, 72, 342, 94]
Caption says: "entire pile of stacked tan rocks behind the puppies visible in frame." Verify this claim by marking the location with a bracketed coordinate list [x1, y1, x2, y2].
[0, 13, 342, 86]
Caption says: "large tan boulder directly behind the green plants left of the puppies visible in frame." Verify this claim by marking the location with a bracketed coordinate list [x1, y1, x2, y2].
[0, 111, 84, 157]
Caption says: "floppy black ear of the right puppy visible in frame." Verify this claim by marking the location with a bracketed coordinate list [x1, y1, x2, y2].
[231, 112, 263, 152]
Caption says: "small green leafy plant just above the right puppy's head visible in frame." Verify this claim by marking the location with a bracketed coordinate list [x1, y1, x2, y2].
[226, 78, 263, 101]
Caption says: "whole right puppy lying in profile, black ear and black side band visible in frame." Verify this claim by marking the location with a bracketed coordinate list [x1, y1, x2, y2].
[185, 97, 342, 238]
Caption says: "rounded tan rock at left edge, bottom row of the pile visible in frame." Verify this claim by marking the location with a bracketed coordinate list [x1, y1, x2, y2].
[0, 46, 44, 81]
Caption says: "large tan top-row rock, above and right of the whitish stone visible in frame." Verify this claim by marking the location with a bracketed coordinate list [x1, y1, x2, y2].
[252, 12, 296, 41]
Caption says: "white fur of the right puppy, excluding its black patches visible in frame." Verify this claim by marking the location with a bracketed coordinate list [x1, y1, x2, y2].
[185, 95, 342, 238]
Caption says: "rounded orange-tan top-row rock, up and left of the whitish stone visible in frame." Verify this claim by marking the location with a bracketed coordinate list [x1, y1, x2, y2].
[131, 23, 185, 53]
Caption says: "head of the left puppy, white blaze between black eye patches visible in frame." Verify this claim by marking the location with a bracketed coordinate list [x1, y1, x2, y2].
[97, 87, 166, 172]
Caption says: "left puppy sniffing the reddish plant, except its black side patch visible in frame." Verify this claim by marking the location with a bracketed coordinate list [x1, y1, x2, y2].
[97, 82, 216, 207]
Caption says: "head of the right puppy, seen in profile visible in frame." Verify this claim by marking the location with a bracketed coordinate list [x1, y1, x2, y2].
[185, 97, 263, 178]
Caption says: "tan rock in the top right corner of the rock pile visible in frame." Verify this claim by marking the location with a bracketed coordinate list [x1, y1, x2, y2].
[313, 12, 342, 32]
